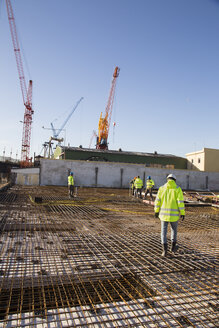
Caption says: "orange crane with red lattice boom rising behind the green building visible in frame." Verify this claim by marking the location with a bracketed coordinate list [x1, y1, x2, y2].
[96, 66, 120, 150]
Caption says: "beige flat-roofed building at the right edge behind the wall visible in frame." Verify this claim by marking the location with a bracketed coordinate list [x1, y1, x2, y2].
[186, 148, 219, 172]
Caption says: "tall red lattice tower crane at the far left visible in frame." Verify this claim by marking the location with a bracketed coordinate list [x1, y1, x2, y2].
[6, 0, 34, 167]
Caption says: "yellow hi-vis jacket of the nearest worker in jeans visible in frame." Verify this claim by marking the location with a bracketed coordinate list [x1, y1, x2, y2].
[154, 180, 185, 222]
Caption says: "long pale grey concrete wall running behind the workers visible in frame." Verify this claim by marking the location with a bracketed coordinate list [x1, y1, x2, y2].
[40, 159, 219, 190]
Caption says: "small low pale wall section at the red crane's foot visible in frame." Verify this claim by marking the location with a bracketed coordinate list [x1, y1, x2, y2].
[11, 167, 40, 186]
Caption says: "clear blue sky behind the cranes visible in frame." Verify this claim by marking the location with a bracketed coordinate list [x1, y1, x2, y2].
[0, 0, 219, 158]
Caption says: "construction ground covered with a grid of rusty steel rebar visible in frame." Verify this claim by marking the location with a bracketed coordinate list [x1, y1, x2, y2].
[0, 185, 219, 328]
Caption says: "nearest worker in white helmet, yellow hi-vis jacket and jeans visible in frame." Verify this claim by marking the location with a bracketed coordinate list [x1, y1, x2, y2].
[154, 174, 185, 256]
